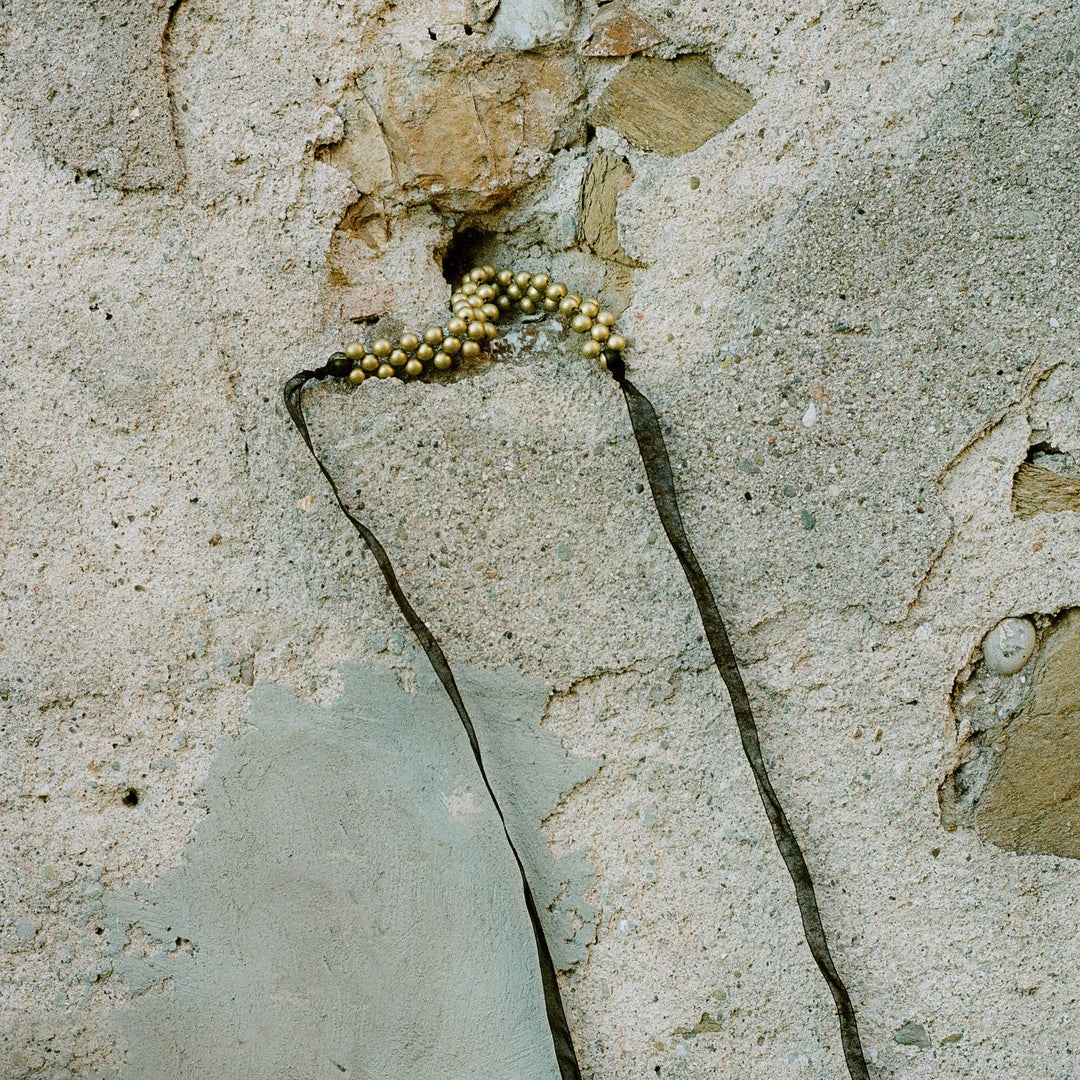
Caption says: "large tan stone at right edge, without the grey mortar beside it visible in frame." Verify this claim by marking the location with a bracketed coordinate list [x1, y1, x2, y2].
[975, 609, 1080, 859]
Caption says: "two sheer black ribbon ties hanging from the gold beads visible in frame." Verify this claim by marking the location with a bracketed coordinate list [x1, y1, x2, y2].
[285, 352, 869, 1080]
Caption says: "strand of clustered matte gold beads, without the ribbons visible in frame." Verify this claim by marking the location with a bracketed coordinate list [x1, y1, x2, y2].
[326, 266, 626, 386]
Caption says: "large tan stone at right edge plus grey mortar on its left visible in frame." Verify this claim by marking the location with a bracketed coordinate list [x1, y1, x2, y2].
[939, 608, 1080, 859]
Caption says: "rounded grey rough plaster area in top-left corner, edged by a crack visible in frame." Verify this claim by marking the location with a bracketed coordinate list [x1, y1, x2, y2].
[0, 0, 180, 190]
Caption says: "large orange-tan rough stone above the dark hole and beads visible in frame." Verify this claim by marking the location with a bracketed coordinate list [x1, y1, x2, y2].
[373, 51, 584, 211]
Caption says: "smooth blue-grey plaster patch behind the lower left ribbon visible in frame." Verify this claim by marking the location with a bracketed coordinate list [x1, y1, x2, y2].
[105, 666, 595, 1080]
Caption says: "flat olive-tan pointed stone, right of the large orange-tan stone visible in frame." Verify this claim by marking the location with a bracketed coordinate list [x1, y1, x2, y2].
[589, 55, 754, 157]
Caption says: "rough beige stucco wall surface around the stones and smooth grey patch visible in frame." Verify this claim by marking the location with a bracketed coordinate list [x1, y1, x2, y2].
[0, 0, 1080, 1080]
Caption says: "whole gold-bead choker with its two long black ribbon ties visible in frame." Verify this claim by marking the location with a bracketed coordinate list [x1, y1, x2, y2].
[284, 266, 869, 1080]
